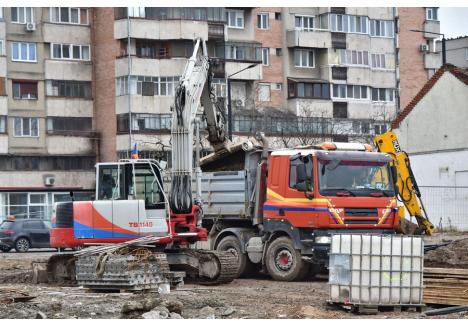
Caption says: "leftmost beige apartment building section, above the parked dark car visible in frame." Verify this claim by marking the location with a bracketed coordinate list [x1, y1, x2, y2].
[0, 7, 97, 219]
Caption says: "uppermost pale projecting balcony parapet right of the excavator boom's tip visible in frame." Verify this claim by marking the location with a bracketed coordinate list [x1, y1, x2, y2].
[286, 29, 332, 49]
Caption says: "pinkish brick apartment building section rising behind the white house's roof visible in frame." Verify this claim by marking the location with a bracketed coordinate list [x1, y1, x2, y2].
[397, 7, 442, 110]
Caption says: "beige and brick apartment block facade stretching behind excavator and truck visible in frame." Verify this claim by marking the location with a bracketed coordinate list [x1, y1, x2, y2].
[0, 7, 434, 219]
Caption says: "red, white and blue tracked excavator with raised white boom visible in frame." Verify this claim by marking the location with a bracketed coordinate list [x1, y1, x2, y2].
[47, 39, 237, 290]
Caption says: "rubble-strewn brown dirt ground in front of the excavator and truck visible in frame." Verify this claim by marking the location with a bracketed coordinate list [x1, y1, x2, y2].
[0, 234, 468, 319]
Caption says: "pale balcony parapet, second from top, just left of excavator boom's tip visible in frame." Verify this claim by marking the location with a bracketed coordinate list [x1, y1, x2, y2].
[115, 56, 187, 77]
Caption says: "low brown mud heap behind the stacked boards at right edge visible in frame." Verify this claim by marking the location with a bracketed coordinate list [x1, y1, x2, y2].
[424, 239, 468, 268]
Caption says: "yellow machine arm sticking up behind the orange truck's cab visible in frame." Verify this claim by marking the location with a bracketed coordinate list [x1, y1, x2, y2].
[374, 131, 434, 235]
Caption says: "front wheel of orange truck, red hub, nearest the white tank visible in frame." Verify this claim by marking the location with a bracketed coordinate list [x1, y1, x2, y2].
[265, 237, 310, 282]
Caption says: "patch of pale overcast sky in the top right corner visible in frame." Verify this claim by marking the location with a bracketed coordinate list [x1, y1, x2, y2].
[439, 7, 468, 38]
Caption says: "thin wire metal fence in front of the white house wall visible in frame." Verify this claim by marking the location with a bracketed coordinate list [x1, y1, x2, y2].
[419, 186, 468, 231]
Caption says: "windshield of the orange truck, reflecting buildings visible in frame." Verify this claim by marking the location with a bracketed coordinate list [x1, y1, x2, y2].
[319, 160, 395, 197]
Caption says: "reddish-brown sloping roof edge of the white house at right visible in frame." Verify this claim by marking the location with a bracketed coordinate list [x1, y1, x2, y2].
[391, 63, 468, 129]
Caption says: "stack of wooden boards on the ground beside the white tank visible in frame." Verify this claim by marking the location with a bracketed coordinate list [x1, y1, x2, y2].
[423, 268, 468, 305]
